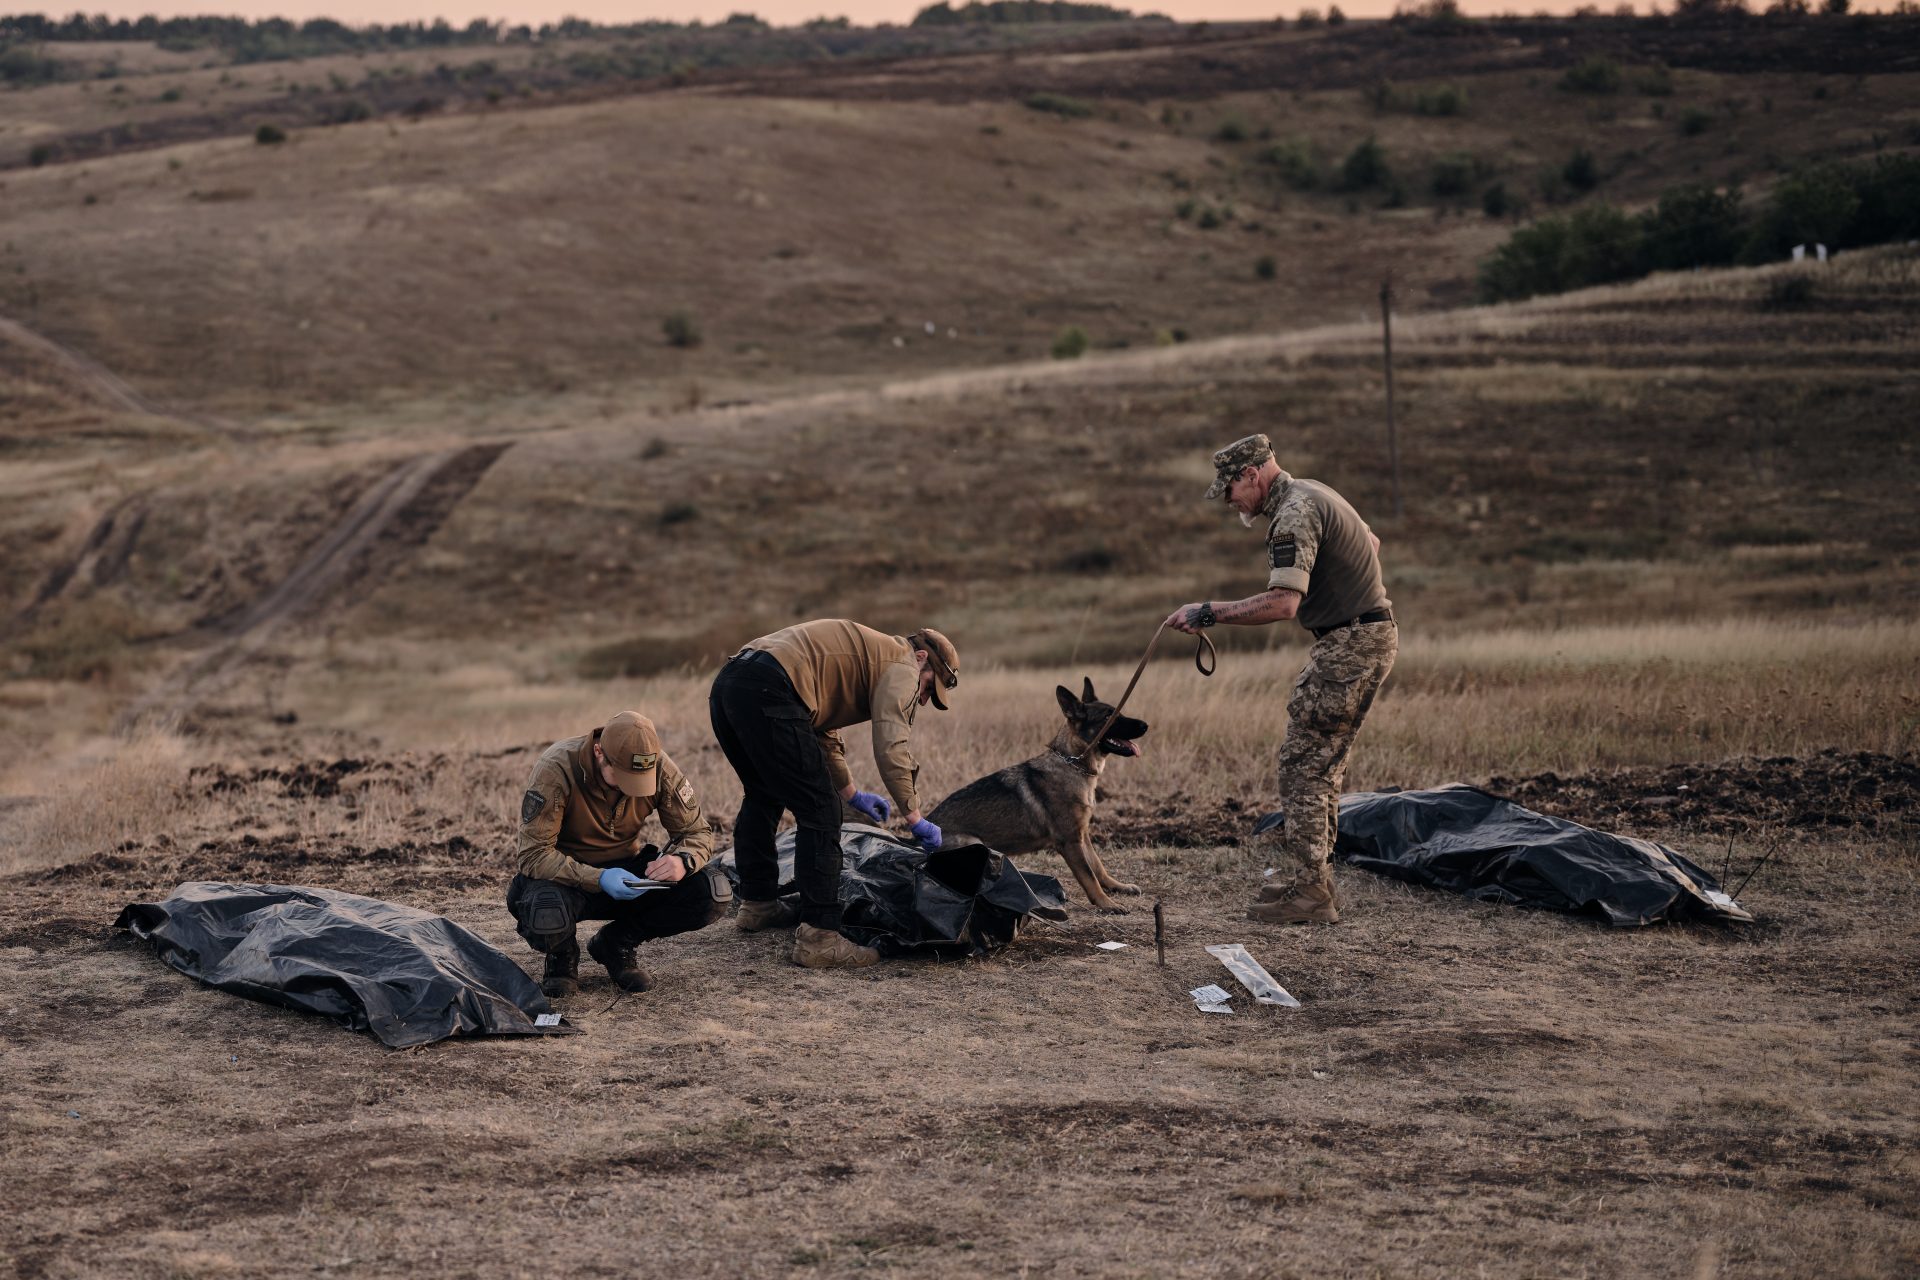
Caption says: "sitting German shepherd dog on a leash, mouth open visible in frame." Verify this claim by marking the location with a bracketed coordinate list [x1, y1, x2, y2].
[927, 679, 1146, 912]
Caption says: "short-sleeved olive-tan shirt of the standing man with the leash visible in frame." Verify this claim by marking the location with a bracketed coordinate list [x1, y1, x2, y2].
[1261, 472, 1392, 631]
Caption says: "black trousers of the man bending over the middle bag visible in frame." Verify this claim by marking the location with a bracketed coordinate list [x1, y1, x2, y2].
[707, 654, 841, 931]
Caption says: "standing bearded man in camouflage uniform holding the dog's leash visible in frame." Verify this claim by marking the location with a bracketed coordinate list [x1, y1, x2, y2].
[1165, 436, 1400, 925]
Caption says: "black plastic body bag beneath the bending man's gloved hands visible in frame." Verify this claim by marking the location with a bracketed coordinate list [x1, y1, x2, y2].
[718, 823, 1068, 956]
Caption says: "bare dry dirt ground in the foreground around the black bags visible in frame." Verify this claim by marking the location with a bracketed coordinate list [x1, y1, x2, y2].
[0, 750, 1920, 1276]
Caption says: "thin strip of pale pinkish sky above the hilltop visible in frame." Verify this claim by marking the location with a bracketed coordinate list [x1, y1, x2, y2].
[52, 0, 1885, 25]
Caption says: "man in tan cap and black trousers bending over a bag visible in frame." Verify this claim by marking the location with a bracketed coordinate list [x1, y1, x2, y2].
[708, 618, 960, 969]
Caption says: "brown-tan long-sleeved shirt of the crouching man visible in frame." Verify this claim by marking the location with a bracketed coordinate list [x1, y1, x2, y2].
[520, 729, 714, 890]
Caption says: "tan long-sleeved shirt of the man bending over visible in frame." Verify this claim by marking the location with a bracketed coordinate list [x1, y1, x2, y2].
[747, 618, 920, 814]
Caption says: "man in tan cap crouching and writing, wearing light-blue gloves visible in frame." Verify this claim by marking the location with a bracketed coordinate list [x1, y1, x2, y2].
[507, 712, 733, 998]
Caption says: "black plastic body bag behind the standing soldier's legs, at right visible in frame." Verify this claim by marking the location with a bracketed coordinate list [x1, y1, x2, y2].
[1254, 785, 1753, 927]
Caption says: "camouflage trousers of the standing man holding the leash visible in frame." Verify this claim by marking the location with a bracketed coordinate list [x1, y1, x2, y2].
[1277, 622, 1400, 875]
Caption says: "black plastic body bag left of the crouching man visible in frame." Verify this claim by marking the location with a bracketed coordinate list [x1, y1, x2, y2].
[113, 881, 570, 1050]
